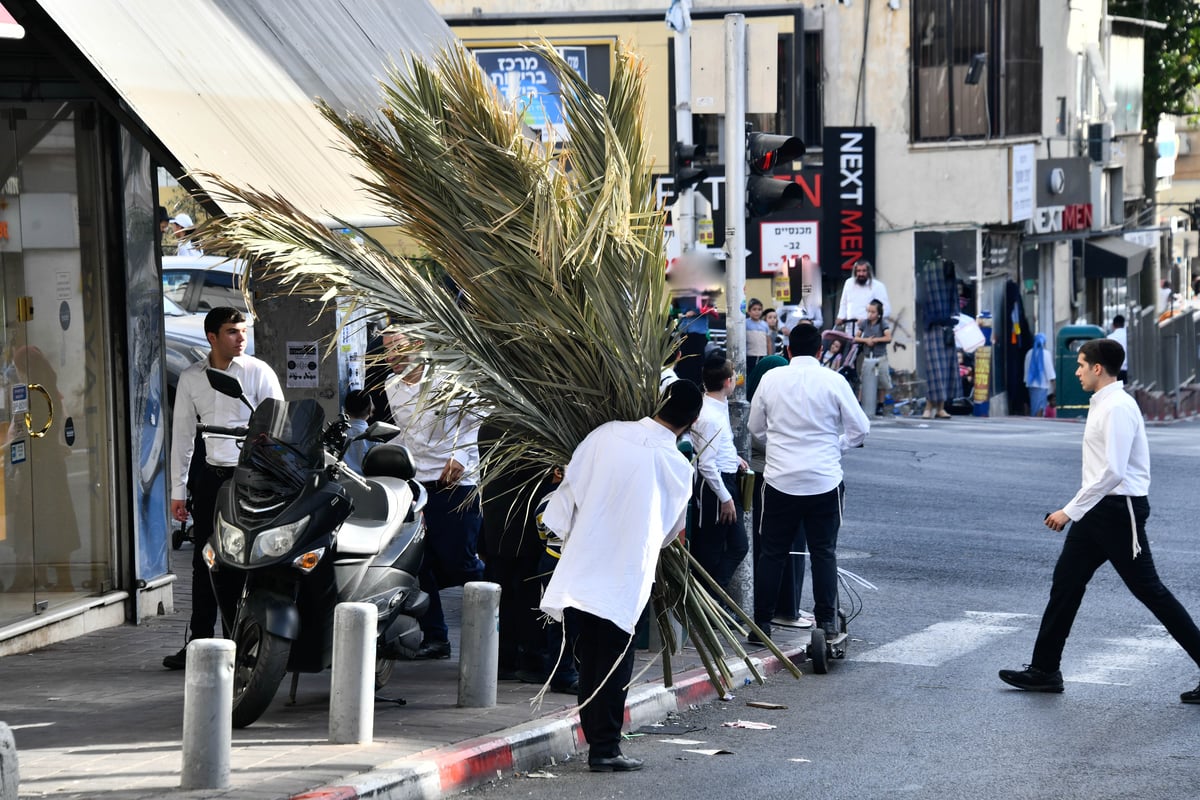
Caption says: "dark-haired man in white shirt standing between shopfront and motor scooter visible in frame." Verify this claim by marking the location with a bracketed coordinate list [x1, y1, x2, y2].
[162, 306, 283, 669]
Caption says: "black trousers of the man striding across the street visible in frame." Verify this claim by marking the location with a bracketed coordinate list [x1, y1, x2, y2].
[1032, 495, 1200, 672]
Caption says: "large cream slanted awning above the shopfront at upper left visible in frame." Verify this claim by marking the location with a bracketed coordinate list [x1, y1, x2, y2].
[38, 0, 454, 225]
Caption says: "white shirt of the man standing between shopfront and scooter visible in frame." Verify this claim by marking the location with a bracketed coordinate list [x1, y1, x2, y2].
[170, 355, 283, 500]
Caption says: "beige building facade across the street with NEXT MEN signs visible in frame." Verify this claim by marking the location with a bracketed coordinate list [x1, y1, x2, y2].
[433, 0, 1158, 414]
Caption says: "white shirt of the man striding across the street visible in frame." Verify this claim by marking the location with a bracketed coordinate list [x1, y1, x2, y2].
[1063, 380, 1150, 521]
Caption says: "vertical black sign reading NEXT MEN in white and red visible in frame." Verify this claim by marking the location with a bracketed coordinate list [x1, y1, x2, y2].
[822, 127, 875, 273]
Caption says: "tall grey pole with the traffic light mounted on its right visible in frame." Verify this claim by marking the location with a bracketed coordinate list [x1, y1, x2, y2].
[725, 14, 750, 461]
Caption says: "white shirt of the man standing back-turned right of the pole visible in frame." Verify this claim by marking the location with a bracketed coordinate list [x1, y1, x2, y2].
[750, 356, 871, 497]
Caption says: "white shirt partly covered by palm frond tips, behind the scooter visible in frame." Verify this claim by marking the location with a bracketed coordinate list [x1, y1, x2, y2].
[385, 375, 480, 486]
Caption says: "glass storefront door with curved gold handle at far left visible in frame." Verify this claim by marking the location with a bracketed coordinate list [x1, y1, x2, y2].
[0, 103, 113, 626]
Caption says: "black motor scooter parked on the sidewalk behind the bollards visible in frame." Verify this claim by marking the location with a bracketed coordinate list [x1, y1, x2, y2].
[197, 368, 430, 728]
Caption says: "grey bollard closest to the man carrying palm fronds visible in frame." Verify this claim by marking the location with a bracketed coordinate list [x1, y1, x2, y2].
[458, 581, 500, 709]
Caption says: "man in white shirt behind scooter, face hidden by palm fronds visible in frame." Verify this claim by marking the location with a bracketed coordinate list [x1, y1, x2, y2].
[382, 330, 484, 658]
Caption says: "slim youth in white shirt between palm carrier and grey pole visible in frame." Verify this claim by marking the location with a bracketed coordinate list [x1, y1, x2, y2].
[689, 359, 750, 589]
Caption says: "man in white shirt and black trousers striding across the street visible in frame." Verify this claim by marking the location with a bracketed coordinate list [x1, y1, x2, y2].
[1000, 339, 1200, 703]
